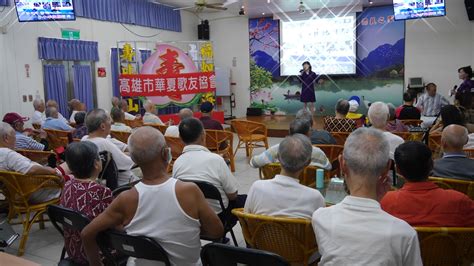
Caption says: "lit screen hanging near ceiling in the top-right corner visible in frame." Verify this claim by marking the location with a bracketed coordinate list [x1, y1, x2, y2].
[393, 0, 446, 20]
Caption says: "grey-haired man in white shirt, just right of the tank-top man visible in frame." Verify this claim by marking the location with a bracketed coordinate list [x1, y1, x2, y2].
[244, 134, 325, 219]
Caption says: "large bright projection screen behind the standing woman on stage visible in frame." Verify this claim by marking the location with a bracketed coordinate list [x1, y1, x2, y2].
[280, 15, 356, 76]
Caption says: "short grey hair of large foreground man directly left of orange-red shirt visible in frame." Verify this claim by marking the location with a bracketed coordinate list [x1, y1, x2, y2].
[343, 128, 390, 178]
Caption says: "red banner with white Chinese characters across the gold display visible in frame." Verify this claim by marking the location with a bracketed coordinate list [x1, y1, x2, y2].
[119, 72, 216, 97]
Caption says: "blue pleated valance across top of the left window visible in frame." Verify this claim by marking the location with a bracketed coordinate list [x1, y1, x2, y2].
[38, 37, 100, 61]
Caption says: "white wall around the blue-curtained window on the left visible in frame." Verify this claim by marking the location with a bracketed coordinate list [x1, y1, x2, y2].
[0, 10, 198, 116]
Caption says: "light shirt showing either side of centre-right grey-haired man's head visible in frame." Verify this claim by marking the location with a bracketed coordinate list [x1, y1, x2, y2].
[250, 144, 332, 170]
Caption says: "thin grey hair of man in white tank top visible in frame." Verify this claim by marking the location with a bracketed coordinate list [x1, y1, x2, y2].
[128, 126, 166, 166]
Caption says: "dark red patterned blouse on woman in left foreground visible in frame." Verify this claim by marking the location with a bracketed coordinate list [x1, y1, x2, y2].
[60, 178, 113, 264]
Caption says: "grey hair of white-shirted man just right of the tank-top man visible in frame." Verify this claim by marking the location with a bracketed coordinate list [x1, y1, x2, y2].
[278, 134, 313, 173]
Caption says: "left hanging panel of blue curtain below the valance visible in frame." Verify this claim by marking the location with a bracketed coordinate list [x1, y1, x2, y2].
[44, 65, 68, 115]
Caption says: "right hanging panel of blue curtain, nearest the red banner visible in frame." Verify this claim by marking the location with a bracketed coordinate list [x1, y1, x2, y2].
[73, 65, 94, 110]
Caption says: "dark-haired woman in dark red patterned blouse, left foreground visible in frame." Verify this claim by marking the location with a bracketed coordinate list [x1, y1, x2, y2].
[60, 141, 113, 265]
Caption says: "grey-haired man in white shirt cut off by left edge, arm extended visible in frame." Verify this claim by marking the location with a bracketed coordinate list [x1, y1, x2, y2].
[0, 122, 61, 203]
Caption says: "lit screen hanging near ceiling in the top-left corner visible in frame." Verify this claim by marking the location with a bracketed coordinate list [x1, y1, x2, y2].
[15, 0, 76, 22]
